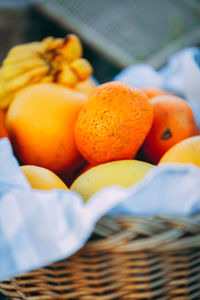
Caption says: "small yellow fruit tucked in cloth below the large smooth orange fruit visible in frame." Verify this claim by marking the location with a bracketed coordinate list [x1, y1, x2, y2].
[20, 165, 68, 190]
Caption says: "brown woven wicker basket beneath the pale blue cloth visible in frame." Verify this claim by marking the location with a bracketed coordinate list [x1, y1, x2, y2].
[0, 214, 200, 300]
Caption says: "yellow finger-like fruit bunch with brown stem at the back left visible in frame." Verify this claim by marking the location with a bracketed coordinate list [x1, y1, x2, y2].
[0, 34, 92, 107]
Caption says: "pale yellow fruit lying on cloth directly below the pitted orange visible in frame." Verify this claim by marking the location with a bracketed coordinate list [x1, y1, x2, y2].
[70, 160, 153, 201]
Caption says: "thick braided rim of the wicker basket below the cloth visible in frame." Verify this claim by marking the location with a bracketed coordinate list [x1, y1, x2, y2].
[85, 213, 200, 252]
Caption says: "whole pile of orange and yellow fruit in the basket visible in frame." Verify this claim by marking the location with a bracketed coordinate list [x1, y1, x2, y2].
[0, 35, 200, 201]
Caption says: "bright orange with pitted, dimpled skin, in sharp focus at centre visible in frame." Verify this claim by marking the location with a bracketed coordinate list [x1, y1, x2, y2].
[75, 81, 153, 165]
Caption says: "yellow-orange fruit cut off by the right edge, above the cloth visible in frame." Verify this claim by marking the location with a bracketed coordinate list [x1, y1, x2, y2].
[160, 135, 200, 167]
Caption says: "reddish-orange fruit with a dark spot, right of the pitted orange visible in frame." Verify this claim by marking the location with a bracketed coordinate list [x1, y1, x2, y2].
[141, 95, 199, 163]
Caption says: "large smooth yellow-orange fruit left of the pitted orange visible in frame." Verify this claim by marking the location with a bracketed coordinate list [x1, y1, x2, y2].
[6, 83, 87, 174]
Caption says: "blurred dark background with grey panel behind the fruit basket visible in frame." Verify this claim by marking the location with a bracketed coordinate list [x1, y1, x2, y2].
[0, 0, 200, 300]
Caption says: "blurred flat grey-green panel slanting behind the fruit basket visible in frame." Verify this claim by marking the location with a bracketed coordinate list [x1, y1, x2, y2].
[37, 0, 200, 68]
